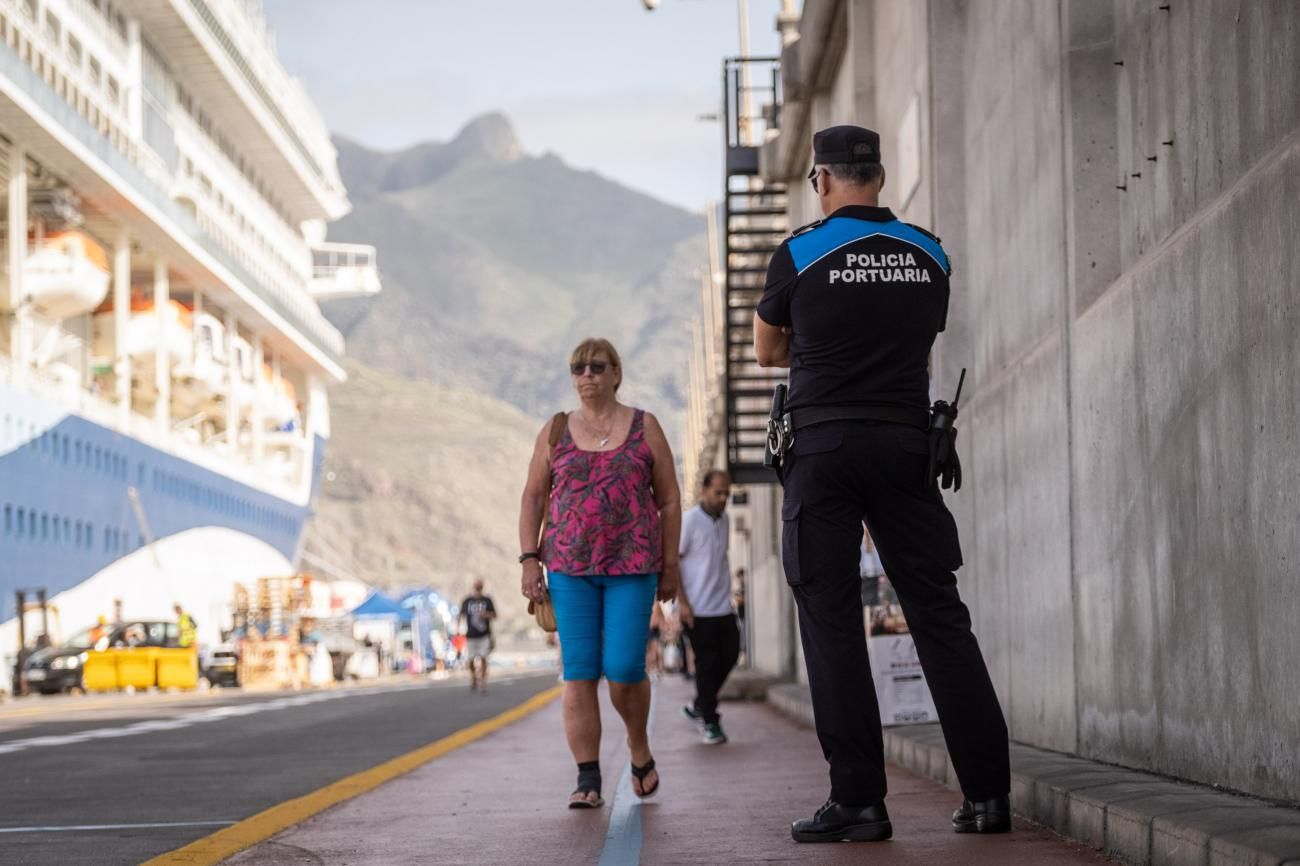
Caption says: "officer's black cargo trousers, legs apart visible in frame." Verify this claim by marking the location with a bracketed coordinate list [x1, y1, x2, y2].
[781, 421, 1011, 806]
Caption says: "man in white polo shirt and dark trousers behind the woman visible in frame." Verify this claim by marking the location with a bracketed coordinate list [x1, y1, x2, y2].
[677, 469, 740, 745]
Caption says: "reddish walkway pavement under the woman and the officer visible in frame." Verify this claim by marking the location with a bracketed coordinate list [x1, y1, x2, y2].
[226, 677, 1109, 866]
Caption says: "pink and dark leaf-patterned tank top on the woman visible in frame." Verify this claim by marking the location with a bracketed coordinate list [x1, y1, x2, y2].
[542, 410, 663, 575]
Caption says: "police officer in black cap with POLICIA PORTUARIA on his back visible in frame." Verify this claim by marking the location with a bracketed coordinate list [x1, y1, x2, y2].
[754, 126, 1011, 841]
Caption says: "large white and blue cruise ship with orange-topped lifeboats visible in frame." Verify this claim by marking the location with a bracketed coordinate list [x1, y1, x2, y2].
[0, 0, 380, 687]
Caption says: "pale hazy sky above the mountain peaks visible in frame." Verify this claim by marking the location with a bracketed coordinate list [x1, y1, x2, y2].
[256, 0, 780, 209]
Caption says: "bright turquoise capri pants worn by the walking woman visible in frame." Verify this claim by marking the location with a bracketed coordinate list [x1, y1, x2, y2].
[546, 571, 659, 685]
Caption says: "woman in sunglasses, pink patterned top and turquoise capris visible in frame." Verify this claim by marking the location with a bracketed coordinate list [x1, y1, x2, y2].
[519, 339, 681, 809]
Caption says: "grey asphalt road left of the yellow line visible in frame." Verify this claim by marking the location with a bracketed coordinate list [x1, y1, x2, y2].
[0, 671, 555, 866]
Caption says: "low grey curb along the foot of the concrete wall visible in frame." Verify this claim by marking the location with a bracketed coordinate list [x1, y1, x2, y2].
[767, 683, 1300, 866]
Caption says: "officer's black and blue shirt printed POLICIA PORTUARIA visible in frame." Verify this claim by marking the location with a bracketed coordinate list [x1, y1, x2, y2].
[758, 205, 950, 410]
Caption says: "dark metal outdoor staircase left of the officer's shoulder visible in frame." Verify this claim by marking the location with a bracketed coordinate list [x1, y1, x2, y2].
[723, 57, 789, 484]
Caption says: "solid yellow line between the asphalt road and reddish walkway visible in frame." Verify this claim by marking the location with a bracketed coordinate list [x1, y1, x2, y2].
[140, 685, 560, 866]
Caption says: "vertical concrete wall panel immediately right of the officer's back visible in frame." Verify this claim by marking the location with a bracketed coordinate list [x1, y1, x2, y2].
[931, 0, 1076, 750]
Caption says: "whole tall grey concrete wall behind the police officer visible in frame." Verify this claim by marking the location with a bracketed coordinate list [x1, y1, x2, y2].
[753, 0, 1300, 801]
